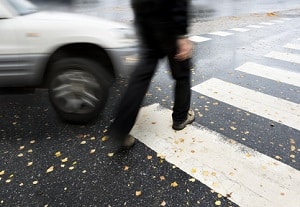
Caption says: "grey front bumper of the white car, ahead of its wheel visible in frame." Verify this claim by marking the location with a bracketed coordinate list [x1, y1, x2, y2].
[106, 47, 139, 78]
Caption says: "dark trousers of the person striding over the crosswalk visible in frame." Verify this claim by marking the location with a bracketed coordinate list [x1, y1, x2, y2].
[110, 27, 191, 141]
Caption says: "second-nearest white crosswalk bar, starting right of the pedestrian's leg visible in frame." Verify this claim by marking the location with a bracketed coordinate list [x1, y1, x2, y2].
[192, 78, 300, 130]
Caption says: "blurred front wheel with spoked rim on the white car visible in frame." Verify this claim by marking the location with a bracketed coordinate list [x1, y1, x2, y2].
[48, 58, 111, 124]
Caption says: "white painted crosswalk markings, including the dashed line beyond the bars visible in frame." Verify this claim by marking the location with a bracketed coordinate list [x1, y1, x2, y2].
[131, 18, 300, 207]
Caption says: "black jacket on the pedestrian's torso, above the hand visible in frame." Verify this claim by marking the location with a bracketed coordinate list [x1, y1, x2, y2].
[131, 0, 189, 36]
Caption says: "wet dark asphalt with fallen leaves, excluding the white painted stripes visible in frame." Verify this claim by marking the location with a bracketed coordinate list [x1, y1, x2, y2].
[0, 0, 300, 207]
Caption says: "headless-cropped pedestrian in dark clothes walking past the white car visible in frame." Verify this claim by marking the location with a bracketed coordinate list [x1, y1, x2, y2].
[108, 0, 195, 149]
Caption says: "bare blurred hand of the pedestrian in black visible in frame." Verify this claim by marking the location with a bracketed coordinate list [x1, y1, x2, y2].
[175, 38, 193, 61]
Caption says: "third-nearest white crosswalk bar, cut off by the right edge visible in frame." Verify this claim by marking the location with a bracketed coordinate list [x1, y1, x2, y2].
[236, 62, 300, 87]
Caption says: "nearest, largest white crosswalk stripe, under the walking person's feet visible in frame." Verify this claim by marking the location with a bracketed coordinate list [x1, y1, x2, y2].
[131, 104, 300, 207]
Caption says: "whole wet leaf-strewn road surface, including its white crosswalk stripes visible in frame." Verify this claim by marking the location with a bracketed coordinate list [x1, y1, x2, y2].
[0, 1, 300, 207]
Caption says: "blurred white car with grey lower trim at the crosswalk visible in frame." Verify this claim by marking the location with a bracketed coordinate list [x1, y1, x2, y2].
[0, 0, 138, 122]
